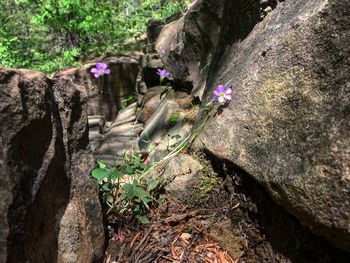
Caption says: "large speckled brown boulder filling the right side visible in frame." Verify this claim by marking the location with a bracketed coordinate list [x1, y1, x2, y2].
[197, 0, 350, 251]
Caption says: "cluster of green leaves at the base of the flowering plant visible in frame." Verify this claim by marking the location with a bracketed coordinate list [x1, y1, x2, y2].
[92, 154, 160, 223]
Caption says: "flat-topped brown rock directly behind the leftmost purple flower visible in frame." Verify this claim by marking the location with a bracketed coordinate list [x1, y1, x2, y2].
[54, 56, 139, 121]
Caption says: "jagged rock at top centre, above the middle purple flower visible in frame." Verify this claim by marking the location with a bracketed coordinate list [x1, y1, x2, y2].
[156, 0, 225, 97]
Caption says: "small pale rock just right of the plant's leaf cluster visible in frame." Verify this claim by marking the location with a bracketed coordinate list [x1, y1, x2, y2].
[162, 153, 203, 202]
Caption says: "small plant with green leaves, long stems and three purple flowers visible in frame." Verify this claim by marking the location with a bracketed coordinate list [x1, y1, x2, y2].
[91, 72, 232, 224]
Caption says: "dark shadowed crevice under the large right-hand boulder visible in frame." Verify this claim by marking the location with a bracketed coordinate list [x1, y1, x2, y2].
[205, 152, 349, 263]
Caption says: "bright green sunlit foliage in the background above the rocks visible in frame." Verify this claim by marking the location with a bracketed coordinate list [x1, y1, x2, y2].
[0, 0, 189, 73]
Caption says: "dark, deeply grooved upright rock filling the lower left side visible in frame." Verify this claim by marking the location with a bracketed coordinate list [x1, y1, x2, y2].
[0, 69, 104, 263]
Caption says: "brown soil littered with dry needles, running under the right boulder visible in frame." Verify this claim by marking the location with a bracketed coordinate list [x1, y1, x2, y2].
[104, 150, 350, 263]
